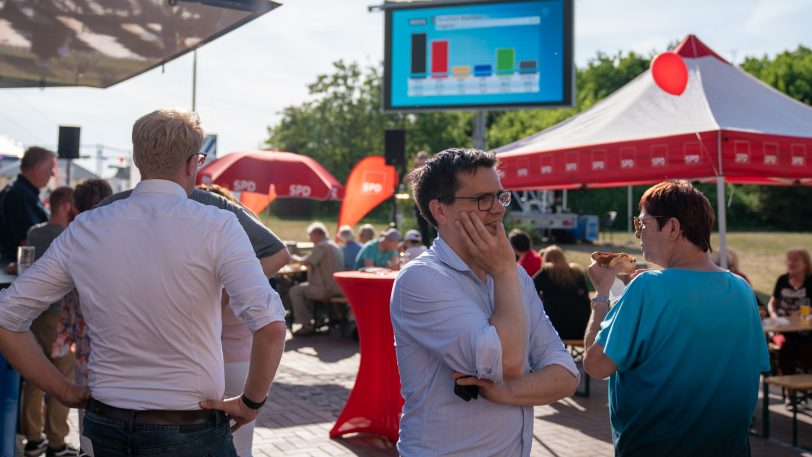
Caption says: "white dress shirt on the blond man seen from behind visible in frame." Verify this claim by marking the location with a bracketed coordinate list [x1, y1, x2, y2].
[0, 180, 284, 410]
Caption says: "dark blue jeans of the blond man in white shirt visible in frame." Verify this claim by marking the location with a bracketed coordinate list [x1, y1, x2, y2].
[82, 411, 237, 457]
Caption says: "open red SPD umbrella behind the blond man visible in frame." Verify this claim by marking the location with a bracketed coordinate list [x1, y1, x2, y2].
[202, 151, 344, 200]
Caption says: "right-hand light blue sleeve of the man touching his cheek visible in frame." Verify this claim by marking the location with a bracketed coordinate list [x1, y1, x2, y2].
[520, 275, 580, 380]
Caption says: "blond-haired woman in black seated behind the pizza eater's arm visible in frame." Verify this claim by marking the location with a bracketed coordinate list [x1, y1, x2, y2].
[533, 245, 591, 340]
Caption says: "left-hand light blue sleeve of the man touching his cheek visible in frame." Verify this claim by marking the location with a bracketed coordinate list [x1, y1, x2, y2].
[392, 268, 502, 383]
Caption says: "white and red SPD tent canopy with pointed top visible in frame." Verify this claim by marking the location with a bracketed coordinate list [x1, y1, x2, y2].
[495, 35, 812, 190]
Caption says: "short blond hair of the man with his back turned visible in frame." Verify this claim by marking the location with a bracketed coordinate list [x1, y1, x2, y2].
[133, 109, 206, 177]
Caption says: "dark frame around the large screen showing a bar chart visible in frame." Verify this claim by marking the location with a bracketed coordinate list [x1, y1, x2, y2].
[381, 0, 575, 113]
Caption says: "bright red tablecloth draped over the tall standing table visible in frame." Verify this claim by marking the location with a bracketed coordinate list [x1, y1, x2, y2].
[330, 271, 403, 441]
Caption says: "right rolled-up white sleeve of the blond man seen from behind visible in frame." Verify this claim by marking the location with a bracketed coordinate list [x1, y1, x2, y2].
[218, 215, 285, 333]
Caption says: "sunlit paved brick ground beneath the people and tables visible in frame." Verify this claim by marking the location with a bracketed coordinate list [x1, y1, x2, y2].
[19, 336, 812, 457]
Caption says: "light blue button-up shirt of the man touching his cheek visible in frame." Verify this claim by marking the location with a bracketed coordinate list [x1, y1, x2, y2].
[390, 237, 578, 457]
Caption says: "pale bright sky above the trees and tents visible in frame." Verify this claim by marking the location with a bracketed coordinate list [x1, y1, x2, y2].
[0, 0, 812, 174]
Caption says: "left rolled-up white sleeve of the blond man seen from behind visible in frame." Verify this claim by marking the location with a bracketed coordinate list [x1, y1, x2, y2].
[0, 229, 74, 332]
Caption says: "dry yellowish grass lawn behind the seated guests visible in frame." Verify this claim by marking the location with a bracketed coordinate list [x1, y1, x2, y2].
[262, 215, 812, 302]
